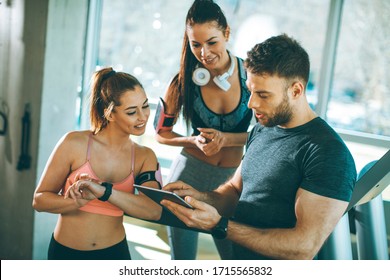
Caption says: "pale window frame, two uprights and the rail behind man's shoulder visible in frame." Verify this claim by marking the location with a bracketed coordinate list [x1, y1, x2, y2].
[78, 0, 390, 148]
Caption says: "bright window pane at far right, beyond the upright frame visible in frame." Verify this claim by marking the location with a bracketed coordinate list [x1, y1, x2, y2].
[326, 0, 390, 137]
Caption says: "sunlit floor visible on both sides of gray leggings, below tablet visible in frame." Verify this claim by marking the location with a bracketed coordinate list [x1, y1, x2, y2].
[124, 216, 220, 260]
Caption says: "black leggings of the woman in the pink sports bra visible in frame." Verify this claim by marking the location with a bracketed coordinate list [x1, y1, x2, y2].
[47, 235, 131, 260]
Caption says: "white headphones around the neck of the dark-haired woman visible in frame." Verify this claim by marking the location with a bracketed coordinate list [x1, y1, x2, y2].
[192, 53, 236, 91]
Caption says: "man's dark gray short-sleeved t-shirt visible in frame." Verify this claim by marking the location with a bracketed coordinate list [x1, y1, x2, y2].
[233, 117, 356, 259]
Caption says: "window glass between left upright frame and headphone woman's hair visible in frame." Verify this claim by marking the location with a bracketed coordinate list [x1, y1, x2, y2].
[97, 0, 192, 99]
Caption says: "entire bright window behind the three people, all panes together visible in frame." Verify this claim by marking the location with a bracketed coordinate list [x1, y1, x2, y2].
[81, 0, 390, 198]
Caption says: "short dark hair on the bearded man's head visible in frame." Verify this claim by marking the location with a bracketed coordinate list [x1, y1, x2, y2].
[245, 34, 310, 86]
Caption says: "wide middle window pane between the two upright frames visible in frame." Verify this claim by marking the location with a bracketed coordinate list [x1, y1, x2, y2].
[94, 0, 329, 174]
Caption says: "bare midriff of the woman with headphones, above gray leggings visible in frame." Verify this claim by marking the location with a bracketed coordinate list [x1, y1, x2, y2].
[184, 147, 243, 167]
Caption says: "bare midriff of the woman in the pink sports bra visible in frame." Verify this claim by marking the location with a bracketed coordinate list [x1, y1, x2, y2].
[54, 210, 125, 250]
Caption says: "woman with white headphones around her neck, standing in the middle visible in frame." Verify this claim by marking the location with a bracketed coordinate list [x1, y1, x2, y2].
[155, 1, 253, 259]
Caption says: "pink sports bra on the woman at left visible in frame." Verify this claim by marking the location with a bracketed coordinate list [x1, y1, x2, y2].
[62, 134, 134, 217]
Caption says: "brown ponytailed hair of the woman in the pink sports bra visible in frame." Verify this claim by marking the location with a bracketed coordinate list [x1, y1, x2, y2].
[89, 67, 143, 134]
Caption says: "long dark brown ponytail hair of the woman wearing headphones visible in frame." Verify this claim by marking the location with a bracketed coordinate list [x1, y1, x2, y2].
[167, 0, 228, 125]
